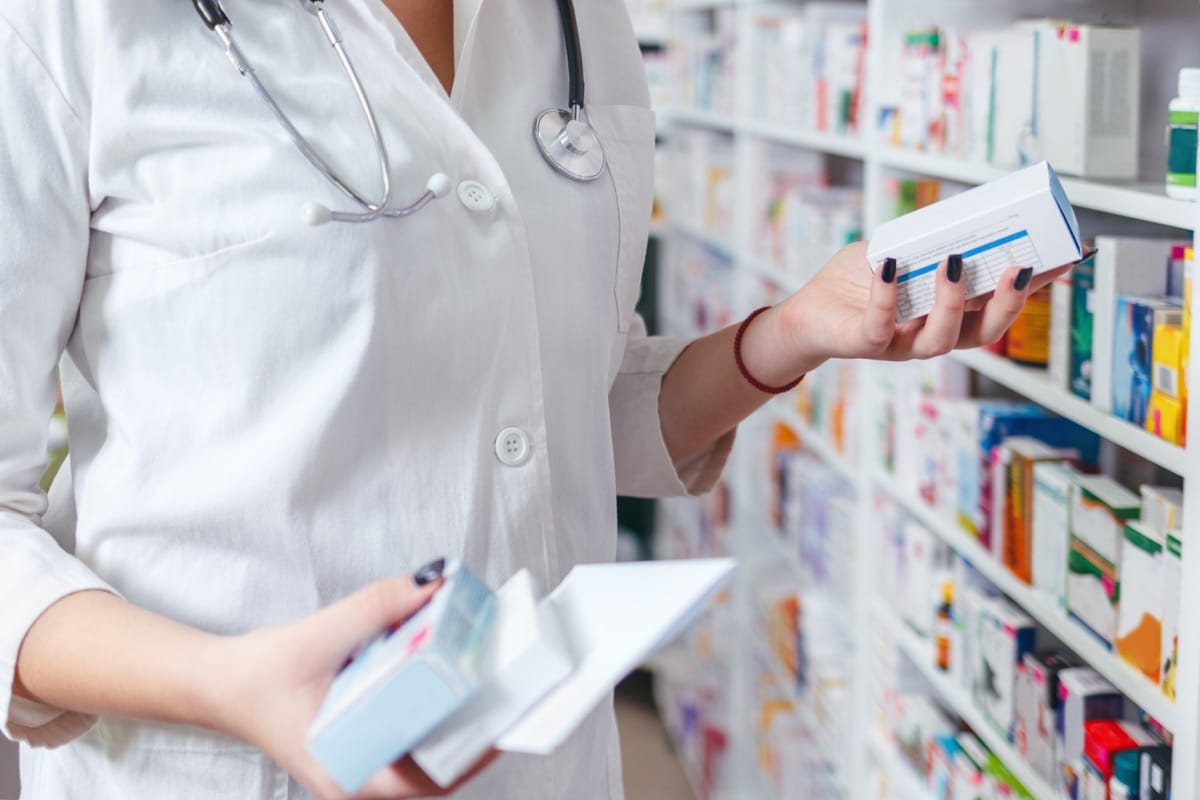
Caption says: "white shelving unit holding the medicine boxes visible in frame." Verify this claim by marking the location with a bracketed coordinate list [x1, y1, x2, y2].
[659, 0, 1200, 800]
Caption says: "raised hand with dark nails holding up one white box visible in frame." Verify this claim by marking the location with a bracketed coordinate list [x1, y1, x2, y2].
[779, 242, 1073, 373]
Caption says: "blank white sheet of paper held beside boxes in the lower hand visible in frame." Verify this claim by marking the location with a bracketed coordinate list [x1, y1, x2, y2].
[497, 559, 734, 756]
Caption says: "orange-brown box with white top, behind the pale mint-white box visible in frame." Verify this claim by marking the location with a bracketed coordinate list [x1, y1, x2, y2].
[994, 437, 1079, 584]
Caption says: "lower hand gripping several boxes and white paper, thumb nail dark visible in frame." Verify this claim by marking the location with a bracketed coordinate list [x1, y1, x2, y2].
[214, 570, 494, 800]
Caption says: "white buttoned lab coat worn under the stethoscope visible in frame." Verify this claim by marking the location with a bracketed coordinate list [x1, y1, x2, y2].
[0, 0, 732, 800]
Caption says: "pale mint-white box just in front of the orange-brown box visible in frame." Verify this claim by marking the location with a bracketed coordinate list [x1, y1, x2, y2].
[1033, 462, 1080, 608]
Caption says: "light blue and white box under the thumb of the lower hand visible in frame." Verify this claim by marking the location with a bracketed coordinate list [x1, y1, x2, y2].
[308, 561, 496, 794]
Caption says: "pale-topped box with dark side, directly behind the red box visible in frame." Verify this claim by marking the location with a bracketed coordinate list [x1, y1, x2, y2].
[1055, 667, 1124, 800]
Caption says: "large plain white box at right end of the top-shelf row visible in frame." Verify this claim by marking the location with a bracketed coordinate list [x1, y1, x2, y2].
[1038, 24, 1141, 179]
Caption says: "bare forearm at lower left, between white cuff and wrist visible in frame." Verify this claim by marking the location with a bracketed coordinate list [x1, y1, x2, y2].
[13, 591, 224, 727]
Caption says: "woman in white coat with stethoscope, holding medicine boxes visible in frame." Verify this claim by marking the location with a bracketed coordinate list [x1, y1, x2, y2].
[0, 0, 1070, 800]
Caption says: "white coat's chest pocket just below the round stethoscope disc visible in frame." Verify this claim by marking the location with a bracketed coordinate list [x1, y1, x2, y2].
[588, 106, 654, 331]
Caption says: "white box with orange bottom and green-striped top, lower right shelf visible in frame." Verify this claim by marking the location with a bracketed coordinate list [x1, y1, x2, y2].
[1115, 522, 1166, 684]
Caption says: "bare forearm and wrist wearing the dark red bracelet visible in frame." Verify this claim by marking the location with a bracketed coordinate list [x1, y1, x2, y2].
[659, 306, 823, 462]
